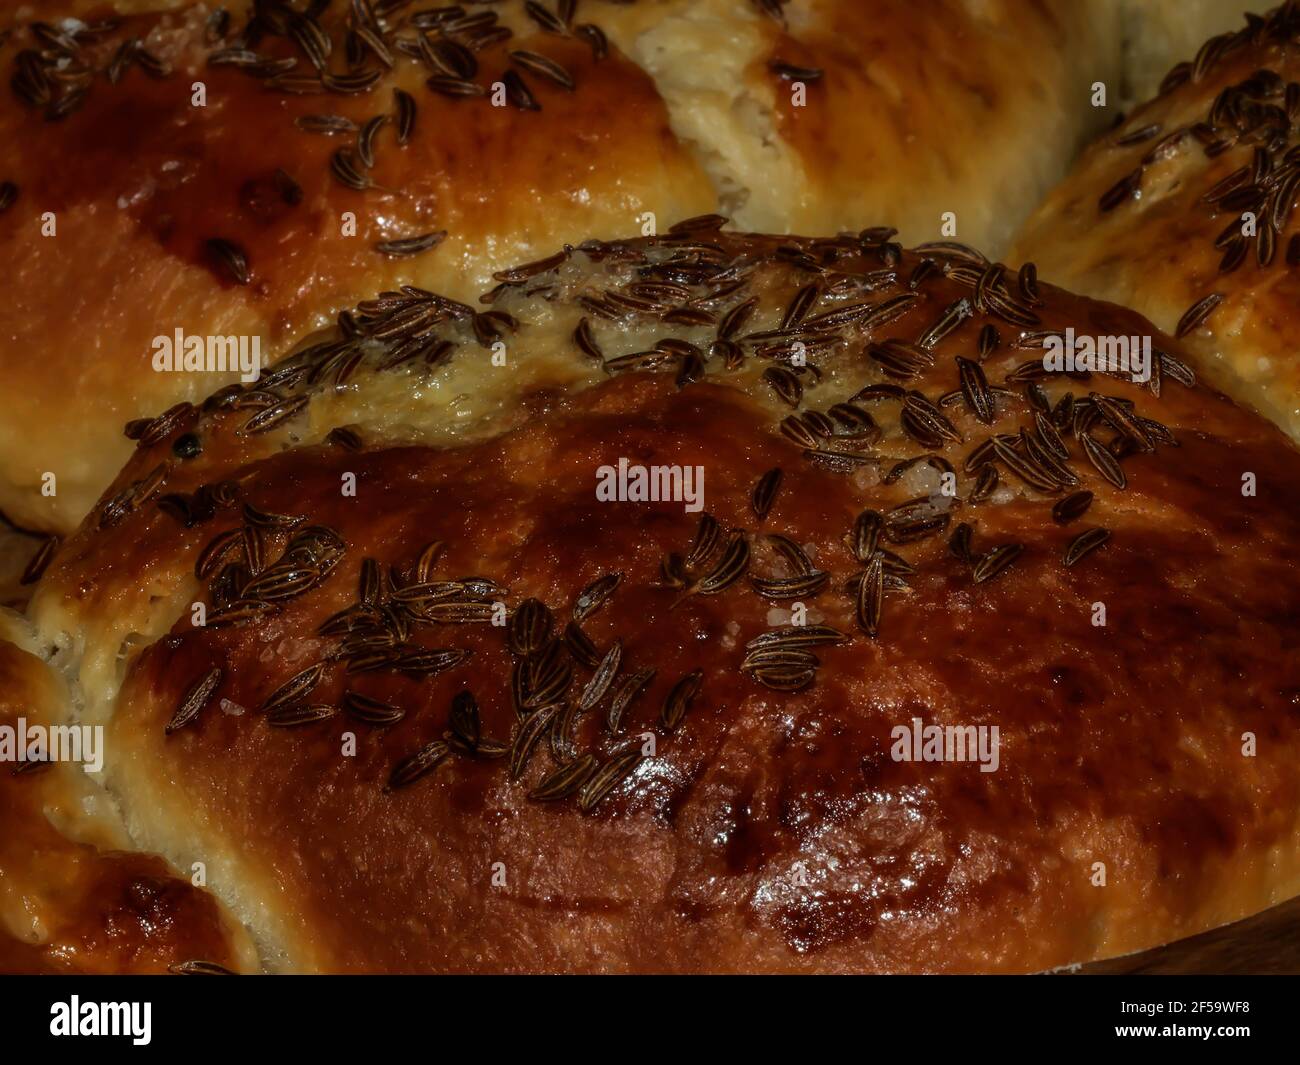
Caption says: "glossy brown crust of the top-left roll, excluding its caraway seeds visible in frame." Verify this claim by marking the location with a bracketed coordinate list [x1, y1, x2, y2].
[0, 5, 714, 532]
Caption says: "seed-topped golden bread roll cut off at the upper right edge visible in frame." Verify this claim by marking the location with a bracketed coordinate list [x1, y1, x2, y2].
[1011, 3, 1300, 437]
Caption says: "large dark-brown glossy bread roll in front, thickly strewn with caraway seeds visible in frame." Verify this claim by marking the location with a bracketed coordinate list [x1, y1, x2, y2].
[17, 218, 1300, 973]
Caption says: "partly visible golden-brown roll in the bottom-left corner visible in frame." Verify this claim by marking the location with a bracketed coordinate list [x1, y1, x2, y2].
[0, 611, 256, 973]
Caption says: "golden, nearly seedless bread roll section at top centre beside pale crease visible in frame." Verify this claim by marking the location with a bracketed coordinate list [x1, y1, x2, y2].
[595, 0, 1121, 243]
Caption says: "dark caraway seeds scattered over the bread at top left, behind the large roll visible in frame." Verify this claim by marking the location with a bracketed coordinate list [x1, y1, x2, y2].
[0, 0, 822, 285]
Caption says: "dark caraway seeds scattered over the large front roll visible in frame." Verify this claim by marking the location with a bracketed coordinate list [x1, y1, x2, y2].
[63, 215, 1195, 809]
